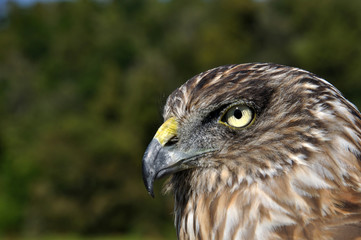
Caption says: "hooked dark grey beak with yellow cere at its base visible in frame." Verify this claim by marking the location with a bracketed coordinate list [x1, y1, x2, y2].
[142, 117, 212, 197]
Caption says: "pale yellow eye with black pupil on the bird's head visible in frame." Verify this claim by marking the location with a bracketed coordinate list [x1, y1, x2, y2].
[221, 104, 255, 128]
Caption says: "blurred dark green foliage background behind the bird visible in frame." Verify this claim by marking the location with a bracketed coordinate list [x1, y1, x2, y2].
[0, 0, 361, 238]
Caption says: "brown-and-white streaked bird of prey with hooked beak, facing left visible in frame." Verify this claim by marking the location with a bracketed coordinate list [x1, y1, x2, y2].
[142, 63, 361, 239]
